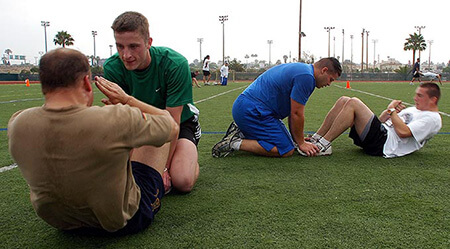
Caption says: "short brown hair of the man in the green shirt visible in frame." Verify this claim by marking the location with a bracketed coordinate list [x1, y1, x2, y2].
[111, 11, 150, 40]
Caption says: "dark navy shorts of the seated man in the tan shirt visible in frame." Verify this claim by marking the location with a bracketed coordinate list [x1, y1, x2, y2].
[68, 161, 164, 235]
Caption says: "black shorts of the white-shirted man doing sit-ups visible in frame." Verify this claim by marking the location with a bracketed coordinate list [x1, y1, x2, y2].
[348, 116, 387, 156]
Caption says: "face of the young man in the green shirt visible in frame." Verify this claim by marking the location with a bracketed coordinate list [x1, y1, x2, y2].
[114, 31, 152, 71]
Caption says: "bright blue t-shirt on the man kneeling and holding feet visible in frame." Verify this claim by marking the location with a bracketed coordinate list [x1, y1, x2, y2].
[242, 63, 316, 119]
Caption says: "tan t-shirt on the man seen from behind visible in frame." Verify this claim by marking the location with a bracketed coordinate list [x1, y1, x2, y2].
[8, 105, 171, 232]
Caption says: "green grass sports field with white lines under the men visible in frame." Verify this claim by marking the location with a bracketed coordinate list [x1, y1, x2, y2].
[0, 82, 450, 248]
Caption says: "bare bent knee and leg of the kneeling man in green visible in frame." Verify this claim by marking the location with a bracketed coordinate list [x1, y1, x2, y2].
[169, 138, 199, 192]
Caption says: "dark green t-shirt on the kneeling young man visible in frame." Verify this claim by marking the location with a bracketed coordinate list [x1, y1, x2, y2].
[103, 47, 198, 123]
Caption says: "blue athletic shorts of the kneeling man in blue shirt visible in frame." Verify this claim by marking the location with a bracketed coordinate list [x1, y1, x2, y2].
[232, 95, 294, 155]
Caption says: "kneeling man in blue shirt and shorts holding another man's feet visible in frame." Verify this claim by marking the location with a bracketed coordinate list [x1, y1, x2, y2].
[212, 57, 342, 157]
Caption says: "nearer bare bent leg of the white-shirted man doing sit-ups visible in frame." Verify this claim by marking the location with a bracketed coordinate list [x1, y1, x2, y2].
[323, 98, 374, 142]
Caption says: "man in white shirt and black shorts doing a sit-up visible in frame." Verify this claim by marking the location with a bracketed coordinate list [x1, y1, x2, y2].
[308, 82, 442, 158]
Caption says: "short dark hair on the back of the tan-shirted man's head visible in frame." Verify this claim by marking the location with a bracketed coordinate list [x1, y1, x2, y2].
[39, 48, 90, 94]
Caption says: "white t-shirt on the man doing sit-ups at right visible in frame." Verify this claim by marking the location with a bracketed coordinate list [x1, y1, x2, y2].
[383, 107, 442, 158]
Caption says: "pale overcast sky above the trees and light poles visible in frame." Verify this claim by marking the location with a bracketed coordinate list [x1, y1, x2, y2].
[0, 0, 450, 66]
